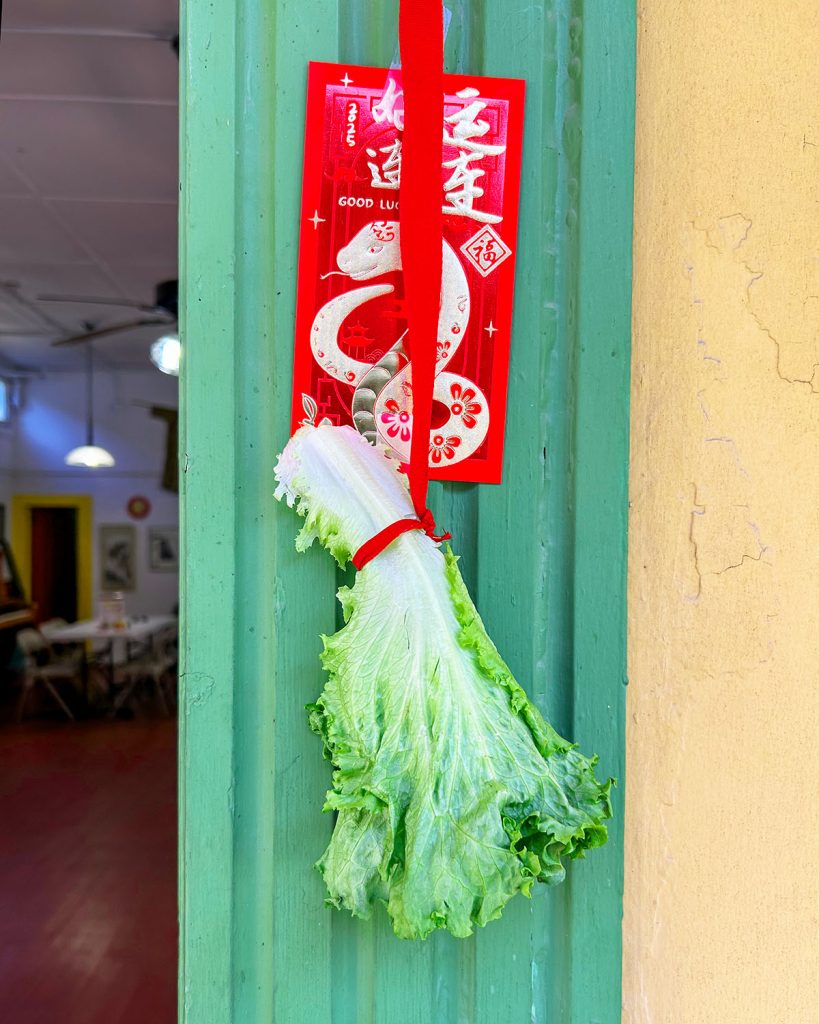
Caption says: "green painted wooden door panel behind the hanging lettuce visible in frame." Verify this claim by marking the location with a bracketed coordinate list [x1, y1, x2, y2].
[180, 0, 635, 1024]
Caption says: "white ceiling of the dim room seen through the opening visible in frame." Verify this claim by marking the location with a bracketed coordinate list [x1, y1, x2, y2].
[0, 0, 178, 370]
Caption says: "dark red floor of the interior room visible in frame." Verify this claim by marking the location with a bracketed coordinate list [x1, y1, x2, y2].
[0, 719, 176, 1024]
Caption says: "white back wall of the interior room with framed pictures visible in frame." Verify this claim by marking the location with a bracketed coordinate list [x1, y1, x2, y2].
[0, 368, 178, 614]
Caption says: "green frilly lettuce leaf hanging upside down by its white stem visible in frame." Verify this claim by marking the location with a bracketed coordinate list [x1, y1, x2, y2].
[276, 426, 611, 938]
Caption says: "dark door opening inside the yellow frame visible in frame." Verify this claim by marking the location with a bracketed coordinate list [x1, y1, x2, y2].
[30, 506, 77, 623]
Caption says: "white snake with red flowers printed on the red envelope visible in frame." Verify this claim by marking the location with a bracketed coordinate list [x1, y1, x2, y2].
[310, 220, 489, 467]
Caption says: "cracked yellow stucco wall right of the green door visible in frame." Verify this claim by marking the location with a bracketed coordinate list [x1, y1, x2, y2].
[623, 0, 819, 1024]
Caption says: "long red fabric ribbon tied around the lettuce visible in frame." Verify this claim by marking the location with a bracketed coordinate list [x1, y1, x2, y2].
[352, 0, 449, 569]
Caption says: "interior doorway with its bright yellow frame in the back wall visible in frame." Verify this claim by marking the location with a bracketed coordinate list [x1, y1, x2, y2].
[11, 495, 92, 622]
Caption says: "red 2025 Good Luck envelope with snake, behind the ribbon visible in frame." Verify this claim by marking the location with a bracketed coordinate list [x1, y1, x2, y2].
[293, 63, 524, 483]
